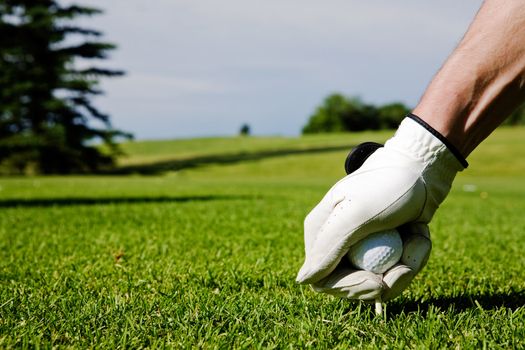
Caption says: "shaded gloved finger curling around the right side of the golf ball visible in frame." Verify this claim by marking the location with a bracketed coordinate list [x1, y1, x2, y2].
[382, 223, 432, 301]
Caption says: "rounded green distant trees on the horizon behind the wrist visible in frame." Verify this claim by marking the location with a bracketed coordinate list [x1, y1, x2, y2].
[302, 93, 525, 134]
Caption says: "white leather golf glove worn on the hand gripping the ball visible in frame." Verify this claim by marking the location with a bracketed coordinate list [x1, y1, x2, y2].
[297, 114, 468, 300]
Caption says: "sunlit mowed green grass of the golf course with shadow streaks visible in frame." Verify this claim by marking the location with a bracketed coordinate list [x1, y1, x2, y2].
[0, 128, 525, 349]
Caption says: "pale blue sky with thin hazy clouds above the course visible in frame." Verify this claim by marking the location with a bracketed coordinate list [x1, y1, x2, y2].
[67, 0, 481, 139]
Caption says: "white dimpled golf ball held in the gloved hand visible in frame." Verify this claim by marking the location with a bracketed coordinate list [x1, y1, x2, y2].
[347, 230, 403, 273]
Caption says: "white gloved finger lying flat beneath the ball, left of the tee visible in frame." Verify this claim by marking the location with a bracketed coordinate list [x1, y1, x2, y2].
[312, 267, 386, 300]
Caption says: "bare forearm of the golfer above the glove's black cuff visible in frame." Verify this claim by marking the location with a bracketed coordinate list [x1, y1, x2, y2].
[414, 0, 525, 157]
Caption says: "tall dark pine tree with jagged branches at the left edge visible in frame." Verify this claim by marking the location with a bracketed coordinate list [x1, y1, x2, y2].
[0, 0, 130, 173]
